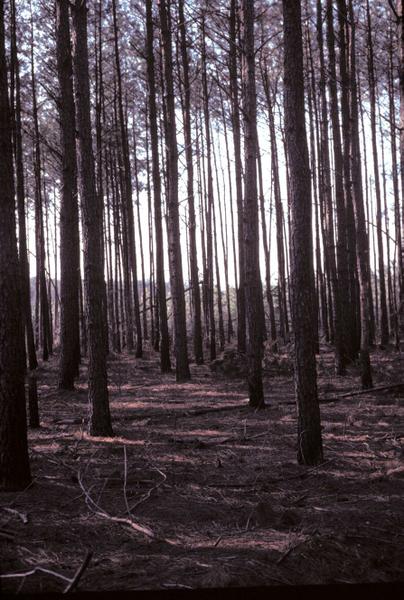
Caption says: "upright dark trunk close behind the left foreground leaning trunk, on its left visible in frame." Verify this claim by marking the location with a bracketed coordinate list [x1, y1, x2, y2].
[56, 0, 80, 389]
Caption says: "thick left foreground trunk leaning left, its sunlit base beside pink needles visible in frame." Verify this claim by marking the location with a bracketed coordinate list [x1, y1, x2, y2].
[72, 0, 113, 436]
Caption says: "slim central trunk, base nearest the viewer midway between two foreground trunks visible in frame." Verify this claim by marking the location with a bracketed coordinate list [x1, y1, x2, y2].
[159, 0, 191, 381]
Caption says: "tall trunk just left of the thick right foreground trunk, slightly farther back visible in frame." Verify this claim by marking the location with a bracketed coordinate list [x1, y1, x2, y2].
[241, 0, 264, 408]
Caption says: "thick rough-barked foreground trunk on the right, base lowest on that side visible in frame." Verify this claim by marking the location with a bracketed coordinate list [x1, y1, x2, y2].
[283, 0, 323, 465]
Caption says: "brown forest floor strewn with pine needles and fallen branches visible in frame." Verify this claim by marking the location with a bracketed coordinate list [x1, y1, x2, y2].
[0, 350, 404, 592]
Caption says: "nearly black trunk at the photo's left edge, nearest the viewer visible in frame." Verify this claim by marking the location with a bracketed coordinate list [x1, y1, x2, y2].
[0, 0, 31, 492]
